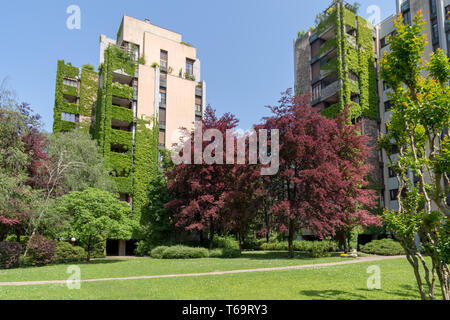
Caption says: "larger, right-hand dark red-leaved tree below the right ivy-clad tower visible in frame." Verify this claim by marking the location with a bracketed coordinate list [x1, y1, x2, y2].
[256, 90, 380, 257]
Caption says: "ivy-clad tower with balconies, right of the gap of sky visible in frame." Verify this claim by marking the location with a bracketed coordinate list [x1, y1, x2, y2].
[294, 1, 382, 189]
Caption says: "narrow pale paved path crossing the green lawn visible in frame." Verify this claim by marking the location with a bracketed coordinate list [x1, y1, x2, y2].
[0, 256, 405, 287]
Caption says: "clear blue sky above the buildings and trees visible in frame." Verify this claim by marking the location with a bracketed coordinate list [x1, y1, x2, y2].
[0, 0, 395, 131]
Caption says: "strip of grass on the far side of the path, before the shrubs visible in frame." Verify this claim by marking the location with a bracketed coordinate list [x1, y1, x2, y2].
[0, 252, 342, 282]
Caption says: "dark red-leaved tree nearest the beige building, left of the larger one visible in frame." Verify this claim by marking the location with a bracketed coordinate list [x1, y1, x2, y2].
[165, 106, 238, 249]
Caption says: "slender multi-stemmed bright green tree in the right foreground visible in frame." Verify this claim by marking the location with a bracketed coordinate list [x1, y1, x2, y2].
[379, 12, 450, 300]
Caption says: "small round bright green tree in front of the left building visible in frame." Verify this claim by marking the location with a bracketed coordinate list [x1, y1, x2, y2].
[57, 188, 134, 261]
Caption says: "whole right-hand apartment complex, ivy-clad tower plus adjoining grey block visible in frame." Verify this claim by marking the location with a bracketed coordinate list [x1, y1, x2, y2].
[294, 0, 450, 215]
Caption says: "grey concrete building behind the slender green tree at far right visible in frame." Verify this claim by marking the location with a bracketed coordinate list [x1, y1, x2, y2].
[376, 0, 450, 210]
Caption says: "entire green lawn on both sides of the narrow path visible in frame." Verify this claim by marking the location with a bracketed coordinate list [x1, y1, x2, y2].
[0, 253, 436, 300]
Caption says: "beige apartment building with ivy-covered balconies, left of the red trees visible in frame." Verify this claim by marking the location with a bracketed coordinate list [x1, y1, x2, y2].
[53, 16, 206, 254]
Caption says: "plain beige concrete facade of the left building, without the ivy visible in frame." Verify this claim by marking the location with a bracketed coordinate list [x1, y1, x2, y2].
[117, 16, 206, 149]
